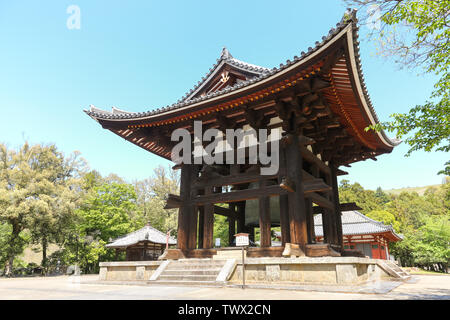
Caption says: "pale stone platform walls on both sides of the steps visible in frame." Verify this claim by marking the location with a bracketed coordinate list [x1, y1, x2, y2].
[100, 258, 392, 285]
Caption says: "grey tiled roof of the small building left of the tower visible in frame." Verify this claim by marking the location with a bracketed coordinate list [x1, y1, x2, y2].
[106, 225, 177, 248]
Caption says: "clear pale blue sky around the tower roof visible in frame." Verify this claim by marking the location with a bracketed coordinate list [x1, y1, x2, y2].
[0, 0, 448, 189]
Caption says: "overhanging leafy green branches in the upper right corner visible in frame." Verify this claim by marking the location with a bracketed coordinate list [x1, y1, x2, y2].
[346, 0, 450, 175]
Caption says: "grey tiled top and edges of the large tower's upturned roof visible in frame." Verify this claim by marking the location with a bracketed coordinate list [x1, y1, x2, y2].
[85, 10, 401, 147]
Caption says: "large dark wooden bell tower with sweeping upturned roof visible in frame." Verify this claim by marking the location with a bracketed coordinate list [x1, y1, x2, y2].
[85, 11, 399, 258]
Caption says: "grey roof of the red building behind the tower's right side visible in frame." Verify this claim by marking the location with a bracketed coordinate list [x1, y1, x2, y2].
[314, 211, 401, 239]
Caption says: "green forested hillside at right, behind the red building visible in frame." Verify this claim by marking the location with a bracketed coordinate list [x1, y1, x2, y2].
[339, 179, 450, 270]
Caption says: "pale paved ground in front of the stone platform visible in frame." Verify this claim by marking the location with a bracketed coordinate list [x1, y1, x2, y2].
[0, 275, 450, 300]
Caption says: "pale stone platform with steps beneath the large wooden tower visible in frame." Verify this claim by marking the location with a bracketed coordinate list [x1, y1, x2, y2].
[100, 251, 408, 286]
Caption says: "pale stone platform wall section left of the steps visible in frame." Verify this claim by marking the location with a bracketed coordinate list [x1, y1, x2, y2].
[100, 261, 162, 281]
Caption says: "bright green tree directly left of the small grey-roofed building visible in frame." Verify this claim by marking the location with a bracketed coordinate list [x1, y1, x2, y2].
[59, 181, 139, 273]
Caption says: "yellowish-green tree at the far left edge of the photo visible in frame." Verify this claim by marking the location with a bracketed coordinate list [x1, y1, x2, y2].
[0, 143, 84, 275]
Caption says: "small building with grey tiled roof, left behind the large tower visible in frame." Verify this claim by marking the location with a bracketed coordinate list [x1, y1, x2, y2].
[106, 224, 177, 261]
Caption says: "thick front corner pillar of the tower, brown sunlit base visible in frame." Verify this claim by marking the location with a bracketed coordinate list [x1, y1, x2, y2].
[281, 134, 308, 252]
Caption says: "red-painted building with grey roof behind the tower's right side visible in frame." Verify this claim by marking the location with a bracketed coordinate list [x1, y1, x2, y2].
[314, 211, 402, 259]
